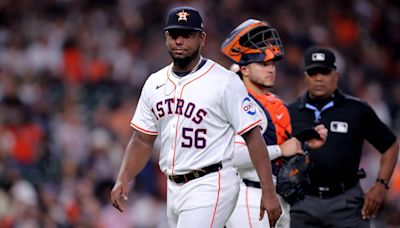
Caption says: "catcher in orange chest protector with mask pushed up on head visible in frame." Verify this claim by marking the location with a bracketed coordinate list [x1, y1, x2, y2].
[221, 19, 327, 228]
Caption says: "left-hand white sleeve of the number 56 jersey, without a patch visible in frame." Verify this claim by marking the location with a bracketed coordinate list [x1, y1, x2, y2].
[131, 80, 158, 135]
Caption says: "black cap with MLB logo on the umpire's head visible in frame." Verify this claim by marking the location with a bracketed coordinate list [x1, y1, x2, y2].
[304, 47, 336, 70]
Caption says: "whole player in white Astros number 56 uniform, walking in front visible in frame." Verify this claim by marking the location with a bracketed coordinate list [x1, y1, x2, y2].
[111, 7, 281, 228]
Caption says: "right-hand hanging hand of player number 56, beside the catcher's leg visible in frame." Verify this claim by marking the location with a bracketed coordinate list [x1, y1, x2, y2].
[260, 189, 282, 227]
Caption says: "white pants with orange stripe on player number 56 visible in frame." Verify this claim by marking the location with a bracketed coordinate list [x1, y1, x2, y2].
[167, 163, 239, 228]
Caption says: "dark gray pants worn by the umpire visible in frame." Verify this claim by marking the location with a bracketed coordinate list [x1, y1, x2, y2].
[290, 183, 370, 228]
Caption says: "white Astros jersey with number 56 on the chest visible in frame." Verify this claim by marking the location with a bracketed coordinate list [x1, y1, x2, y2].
[131, 60, 261, 175]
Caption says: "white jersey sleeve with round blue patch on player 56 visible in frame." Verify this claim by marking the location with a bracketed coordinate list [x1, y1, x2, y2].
[222, 75, 261, 135]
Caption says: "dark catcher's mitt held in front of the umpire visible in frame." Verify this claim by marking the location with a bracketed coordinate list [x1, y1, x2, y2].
[276, 155, 311, 205]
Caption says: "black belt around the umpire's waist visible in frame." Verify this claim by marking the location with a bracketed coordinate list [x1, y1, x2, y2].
[306, 182, 357, 199]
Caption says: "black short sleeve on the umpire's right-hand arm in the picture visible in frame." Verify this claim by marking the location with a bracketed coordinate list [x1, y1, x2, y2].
[362, 103, 396, 153]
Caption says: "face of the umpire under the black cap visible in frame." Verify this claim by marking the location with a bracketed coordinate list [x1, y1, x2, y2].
[304, 68, 339, 98]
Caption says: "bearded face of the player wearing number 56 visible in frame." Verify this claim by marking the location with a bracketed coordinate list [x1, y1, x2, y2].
[165, 29, 206, 65]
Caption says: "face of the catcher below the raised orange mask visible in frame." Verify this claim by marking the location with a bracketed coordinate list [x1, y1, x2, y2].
[241, 61, 276, 89]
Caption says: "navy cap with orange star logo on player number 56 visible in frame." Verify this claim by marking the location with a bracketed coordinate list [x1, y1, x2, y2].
[164, 6, 203, 31]
